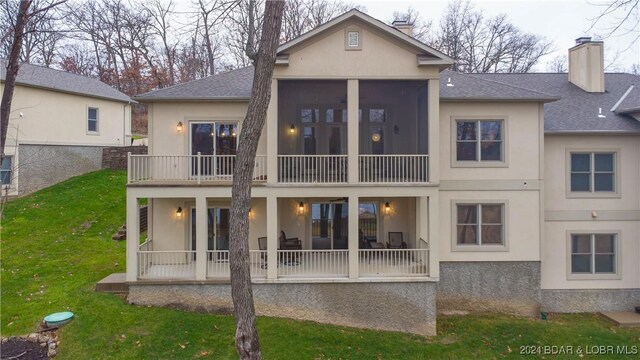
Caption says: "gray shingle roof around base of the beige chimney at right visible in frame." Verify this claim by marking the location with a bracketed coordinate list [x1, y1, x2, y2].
[474, 73, 640, 133]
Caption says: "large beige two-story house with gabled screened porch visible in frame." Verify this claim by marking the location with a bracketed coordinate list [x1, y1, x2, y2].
[126, 10, 640, 334]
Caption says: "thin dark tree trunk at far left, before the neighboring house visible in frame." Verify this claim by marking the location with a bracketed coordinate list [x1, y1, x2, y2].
[0, 0, 31, 159]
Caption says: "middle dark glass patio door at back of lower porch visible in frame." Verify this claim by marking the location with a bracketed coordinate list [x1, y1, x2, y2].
[311, 202, 349, 250]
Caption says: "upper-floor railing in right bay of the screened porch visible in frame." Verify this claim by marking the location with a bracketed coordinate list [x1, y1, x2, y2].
[359, 155, 429, 183]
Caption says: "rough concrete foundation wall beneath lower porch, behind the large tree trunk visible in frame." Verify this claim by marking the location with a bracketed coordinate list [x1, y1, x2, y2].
[128, 282, 436, 336]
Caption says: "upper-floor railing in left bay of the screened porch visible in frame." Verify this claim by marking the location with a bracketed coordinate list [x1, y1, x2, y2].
[278, 155, 347, 184]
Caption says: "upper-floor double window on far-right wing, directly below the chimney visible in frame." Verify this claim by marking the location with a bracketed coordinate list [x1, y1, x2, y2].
[569, 152, 616, 193]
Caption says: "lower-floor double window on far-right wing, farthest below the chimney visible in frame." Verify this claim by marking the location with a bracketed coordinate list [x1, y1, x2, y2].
[569, 233, 619, 279]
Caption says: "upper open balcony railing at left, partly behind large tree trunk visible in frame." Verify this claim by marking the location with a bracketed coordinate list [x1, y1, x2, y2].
[127, 154, 267, 183]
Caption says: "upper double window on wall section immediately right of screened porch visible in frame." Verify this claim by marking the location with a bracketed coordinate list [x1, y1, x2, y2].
[455, 120, 504, 163]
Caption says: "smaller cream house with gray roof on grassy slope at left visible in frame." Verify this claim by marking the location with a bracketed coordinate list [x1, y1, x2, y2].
[0, 60, 133, 195]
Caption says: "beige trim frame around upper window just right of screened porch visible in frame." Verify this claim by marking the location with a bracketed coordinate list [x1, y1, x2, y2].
[450, 115, 509, 168]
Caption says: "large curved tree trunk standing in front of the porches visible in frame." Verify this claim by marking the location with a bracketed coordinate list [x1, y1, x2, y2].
[229, 0, 284, 359]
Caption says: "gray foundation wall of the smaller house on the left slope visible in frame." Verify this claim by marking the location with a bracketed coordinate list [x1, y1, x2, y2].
[18, 144, 104, 195]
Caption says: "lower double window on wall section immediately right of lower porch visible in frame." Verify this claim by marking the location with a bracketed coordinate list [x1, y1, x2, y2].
[455, 203, 505, 250]
